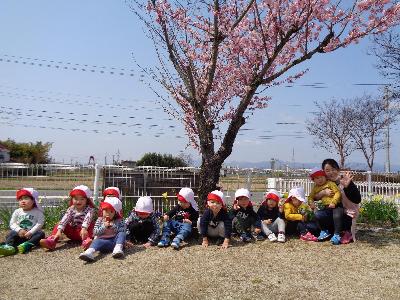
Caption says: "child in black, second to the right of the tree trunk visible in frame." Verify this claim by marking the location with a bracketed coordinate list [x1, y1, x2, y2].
[230, 188, 261, 243]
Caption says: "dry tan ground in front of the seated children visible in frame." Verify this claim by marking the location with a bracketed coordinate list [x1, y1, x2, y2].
[0, 230, 400, 299]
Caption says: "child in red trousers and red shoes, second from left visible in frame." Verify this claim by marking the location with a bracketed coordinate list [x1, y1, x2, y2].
[40, 185, 95, 250]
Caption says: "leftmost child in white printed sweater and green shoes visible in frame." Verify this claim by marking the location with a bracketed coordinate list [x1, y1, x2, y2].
[0, 188, 44, 256]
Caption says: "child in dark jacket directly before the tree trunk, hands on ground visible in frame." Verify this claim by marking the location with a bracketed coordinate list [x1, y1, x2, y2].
[197, 191, 232, 249]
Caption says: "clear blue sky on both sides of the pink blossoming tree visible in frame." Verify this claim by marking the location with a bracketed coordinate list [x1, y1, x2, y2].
[0, 0, 400, 170]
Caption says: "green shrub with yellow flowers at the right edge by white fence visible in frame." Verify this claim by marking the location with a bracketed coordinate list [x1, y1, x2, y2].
[359, 196, 399, 226]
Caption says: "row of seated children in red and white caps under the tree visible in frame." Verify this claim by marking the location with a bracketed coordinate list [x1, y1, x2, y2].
[0, 166, 350, 261]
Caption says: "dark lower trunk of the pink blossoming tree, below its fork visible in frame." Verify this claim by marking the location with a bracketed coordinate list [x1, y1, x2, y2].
[198, 157, 222, 212]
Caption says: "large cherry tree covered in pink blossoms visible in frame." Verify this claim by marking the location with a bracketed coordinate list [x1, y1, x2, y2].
[131, 0, 400, 206]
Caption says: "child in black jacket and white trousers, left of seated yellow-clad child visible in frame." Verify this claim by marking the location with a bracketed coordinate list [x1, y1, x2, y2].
[257, 190, 286, 243]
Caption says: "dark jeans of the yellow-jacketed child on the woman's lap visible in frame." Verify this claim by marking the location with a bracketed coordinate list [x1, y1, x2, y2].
[315, 207, 343, 234]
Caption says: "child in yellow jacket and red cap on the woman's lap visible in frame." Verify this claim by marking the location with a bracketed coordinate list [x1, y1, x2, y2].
[308, 168, 343, 245]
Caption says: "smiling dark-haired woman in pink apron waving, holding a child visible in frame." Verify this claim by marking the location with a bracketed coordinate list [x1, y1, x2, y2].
[315, 158, 361, 244]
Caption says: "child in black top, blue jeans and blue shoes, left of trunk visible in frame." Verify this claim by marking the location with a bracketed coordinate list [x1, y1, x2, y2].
[158, 188, 199, 250]
